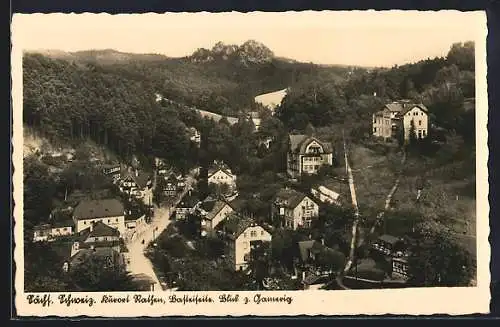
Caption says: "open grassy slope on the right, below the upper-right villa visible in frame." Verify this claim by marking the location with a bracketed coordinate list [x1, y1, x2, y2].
[337, 144, 476, 255]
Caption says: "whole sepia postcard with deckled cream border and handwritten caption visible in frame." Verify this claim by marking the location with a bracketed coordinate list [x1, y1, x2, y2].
[12, 11, 490, 317]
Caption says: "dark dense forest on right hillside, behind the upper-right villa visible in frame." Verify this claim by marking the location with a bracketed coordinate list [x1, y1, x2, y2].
[277, 42, 475, 141]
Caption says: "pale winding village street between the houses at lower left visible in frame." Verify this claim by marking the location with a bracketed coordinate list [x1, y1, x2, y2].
[126, 174, 194, 291]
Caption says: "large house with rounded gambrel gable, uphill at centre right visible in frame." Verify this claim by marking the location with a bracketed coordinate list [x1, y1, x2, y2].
[287, 135, 333, 178]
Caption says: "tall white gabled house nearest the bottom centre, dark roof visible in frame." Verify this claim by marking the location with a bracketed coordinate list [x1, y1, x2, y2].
[223, 214, 272, 271]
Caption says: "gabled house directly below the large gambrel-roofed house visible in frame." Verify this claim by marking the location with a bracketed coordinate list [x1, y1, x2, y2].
[271, 188, 319, 230]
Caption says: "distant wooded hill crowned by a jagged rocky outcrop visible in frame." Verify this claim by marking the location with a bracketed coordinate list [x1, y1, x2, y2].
[26, 40, 354, 116]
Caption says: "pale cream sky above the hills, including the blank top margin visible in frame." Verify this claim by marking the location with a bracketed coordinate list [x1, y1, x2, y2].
[12, 10, 486, 67]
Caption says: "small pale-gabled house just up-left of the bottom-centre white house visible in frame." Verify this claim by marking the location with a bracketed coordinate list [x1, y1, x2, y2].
[196, 196, 234, 236]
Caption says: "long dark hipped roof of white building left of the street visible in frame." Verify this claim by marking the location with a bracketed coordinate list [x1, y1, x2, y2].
[73, 199, 124, 220]
